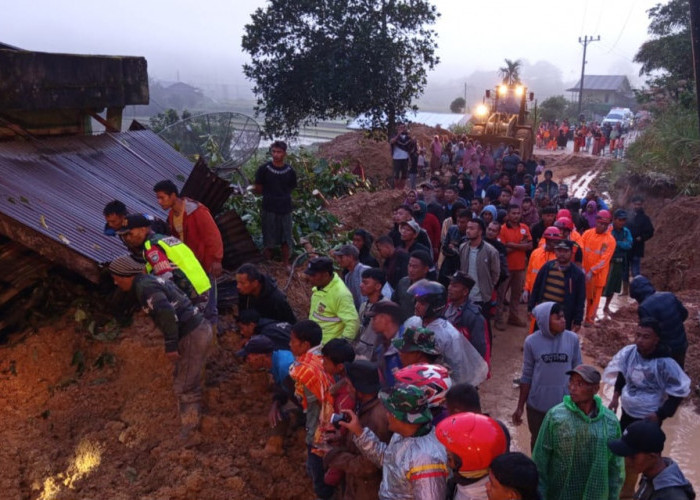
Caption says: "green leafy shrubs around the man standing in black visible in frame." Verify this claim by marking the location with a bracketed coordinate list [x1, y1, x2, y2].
[228, 149, 372, 252]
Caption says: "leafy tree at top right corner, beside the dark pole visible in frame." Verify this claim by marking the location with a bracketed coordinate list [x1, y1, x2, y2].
[634, 0, 694, 89]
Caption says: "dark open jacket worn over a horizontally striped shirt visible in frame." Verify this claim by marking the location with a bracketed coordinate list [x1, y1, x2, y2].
[527, 260, 586, 330]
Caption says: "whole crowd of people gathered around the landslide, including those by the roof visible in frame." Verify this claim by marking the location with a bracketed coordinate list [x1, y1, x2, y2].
[100, 138, 694, 500]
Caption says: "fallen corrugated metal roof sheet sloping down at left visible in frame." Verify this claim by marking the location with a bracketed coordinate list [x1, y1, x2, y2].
[0, 131, 192, 280]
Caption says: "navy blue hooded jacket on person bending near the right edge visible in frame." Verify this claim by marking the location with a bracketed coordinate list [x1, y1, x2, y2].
[630, 275, 688, 354]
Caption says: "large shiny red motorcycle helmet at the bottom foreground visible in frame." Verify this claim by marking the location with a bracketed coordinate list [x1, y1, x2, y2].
[435, 413, 506, 472]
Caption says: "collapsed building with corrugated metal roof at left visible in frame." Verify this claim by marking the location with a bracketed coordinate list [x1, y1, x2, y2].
[0, 44, 260, 332]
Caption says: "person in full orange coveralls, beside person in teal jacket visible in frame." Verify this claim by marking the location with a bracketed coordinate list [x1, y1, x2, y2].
[581, 210, 616, 327]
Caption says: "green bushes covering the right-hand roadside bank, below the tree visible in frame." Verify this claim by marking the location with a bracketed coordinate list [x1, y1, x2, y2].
[626, 105, 700, 195]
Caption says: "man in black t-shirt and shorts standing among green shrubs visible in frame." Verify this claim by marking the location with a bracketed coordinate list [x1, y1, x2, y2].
[255, 141, 297, 267]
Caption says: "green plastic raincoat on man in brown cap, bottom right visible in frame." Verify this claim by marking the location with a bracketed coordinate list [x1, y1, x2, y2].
[532, 395, 625, 500]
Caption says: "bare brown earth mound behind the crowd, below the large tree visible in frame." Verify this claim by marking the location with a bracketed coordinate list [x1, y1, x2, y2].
[319, 124, 452, 182]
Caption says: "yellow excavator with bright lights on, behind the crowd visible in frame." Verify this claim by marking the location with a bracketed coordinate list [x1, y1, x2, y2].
[467, 83, 535, 161]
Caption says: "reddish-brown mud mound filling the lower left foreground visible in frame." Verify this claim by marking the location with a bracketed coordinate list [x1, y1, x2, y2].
[0, 313, 313, 500]
